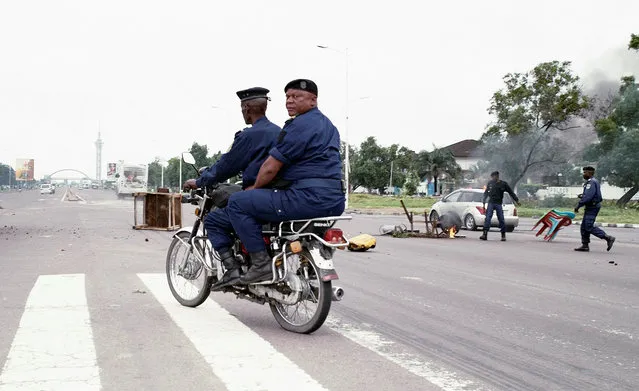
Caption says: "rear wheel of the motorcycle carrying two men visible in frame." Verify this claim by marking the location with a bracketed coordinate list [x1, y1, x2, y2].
[270, 250, 332, 334]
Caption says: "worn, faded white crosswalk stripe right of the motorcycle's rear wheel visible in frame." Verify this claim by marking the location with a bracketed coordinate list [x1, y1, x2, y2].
[326, 316, 482, 391]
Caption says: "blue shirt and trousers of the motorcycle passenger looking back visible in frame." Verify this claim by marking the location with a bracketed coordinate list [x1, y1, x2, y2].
[226, 108, 345, 253]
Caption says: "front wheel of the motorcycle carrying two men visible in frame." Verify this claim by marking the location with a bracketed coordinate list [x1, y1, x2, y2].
[166, 232, 213, 307]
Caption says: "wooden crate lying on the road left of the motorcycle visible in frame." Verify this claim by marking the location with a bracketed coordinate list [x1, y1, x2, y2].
[133, 193, 182, 231]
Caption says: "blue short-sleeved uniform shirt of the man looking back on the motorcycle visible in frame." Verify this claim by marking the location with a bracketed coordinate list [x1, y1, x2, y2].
[270, 107, 342, 181]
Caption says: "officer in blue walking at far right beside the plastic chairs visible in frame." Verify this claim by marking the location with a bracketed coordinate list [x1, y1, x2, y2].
[575, 166, 615, 251]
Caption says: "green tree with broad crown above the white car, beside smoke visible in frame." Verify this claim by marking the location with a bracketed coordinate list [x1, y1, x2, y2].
[482, 61, 589, 187]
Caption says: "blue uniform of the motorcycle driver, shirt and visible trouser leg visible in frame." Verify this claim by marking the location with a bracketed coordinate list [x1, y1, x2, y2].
[204, 116, 281, 252]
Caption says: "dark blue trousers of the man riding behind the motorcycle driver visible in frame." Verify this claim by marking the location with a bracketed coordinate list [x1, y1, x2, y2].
[226, 188, 344, 253]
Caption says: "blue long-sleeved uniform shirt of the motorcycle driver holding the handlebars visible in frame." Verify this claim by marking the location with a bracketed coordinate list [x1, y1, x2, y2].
[196, 117, 281, 188]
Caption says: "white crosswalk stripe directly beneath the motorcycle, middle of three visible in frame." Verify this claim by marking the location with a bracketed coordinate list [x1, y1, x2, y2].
[138, 274, 326, 391]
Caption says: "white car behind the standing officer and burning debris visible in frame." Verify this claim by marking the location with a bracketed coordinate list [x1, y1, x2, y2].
[430, 189, 519, 232]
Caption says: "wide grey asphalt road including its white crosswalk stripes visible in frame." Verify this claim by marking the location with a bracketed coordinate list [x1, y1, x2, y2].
[0, 189, 639, 391]
